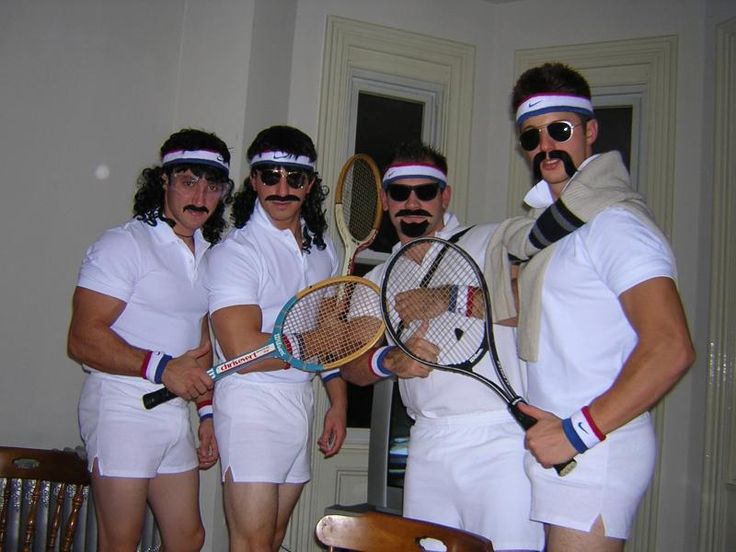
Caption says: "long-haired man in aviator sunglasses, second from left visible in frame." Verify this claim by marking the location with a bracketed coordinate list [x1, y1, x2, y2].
[208, 126, 347, 552]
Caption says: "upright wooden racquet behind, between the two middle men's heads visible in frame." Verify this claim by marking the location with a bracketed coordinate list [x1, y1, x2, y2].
[335, 153, 383, 276]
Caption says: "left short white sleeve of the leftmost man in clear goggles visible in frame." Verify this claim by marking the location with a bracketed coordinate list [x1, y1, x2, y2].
[77, 228, 140, 303]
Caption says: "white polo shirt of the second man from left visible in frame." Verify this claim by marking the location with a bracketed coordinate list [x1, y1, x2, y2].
[207, 201, 338, 382]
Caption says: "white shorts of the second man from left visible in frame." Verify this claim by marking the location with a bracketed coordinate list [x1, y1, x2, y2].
[213, 380, 314, 483]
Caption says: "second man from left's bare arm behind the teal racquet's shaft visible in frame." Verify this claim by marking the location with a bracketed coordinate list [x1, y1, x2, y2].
[210, 305, 285, 374]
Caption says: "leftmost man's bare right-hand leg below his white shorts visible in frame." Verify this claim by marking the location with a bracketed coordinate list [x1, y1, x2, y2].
[148, 469, 204, 552]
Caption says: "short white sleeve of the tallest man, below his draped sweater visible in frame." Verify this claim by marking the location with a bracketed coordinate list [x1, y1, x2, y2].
[585, 208, 676, 296]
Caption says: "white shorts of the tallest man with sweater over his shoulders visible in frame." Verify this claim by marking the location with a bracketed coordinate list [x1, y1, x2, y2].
[524, 413, 656, 539]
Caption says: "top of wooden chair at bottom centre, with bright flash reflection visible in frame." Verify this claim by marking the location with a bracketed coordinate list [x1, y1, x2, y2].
[316, 511, 493, 552]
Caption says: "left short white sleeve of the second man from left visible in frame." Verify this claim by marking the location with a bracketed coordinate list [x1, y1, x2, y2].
[206, 240, 261, 313]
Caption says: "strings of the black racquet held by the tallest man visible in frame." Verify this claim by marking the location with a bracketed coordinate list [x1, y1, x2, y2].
[383, 240, 504, 392]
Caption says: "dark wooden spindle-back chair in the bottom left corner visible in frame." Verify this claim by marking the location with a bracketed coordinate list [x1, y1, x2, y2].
[0, 446, 90, 552]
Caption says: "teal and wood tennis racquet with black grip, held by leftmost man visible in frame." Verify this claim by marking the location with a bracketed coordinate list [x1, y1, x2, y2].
[143, 276, 385, 409]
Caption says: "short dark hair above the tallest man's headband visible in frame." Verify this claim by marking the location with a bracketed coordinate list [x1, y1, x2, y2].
[511, 62, 591, 114]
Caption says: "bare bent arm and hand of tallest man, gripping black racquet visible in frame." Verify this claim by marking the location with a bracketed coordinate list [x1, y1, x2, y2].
[521, 277, 695, 467]
